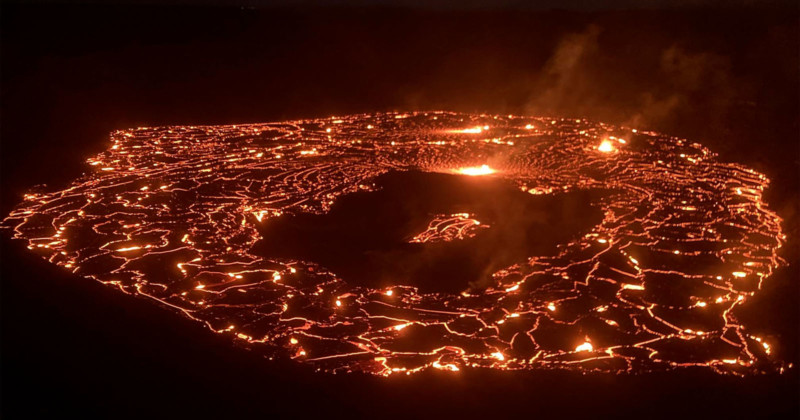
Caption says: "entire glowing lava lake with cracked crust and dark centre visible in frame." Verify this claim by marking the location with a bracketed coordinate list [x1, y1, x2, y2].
[3, 112, 786, 375]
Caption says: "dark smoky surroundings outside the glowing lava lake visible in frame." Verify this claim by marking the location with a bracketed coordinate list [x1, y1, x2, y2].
[0, 0, 800, 418]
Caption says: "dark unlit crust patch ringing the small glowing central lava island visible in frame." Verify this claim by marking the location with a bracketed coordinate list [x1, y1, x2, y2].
[252, 171, 604, 293]
